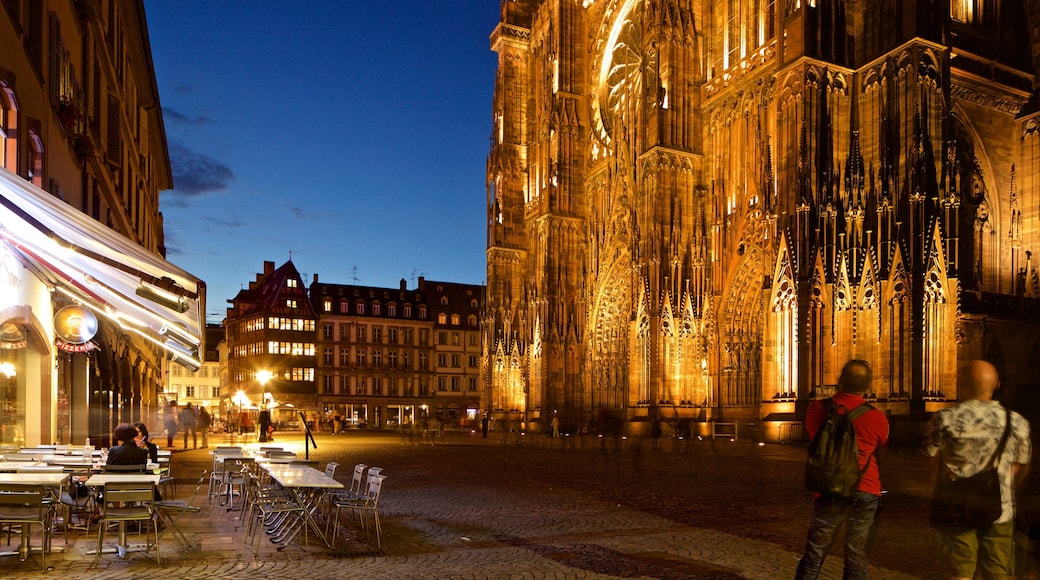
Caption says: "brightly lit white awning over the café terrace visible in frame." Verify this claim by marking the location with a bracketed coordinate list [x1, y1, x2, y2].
[0, 168, 206, 370]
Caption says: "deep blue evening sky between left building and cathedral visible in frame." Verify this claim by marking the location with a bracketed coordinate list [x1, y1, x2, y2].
[145, 0, 498, 322]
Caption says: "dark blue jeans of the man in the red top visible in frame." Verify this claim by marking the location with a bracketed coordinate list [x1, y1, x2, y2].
[795, 492, 881, 580]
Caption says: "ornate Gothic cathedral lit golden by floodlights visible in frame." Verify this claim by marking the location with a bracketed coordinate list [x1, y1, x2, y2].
[483, 0, 1040, 441]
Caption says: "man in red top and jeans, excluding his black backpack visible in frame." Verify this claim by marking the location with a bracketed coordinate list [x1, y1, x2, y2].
[796, 359, 888, 580]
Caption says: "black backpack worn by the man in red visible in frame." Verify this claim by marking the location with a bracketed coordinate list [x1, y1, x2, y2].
[805, 398, 874, 498]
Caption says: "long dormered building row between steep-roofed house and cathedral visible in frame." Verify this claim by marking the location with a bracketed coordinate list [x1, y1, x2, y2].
[310, 275, 484, 428]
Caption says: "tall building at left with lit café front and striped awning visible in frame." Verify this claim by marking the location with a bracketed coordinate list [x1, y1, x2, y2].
[0, 0, 205, 446]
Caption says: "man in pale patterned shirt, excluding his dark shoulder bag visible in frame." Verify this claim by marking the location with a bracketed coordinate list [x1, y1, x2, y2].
[924, 361, 1032, 579]
